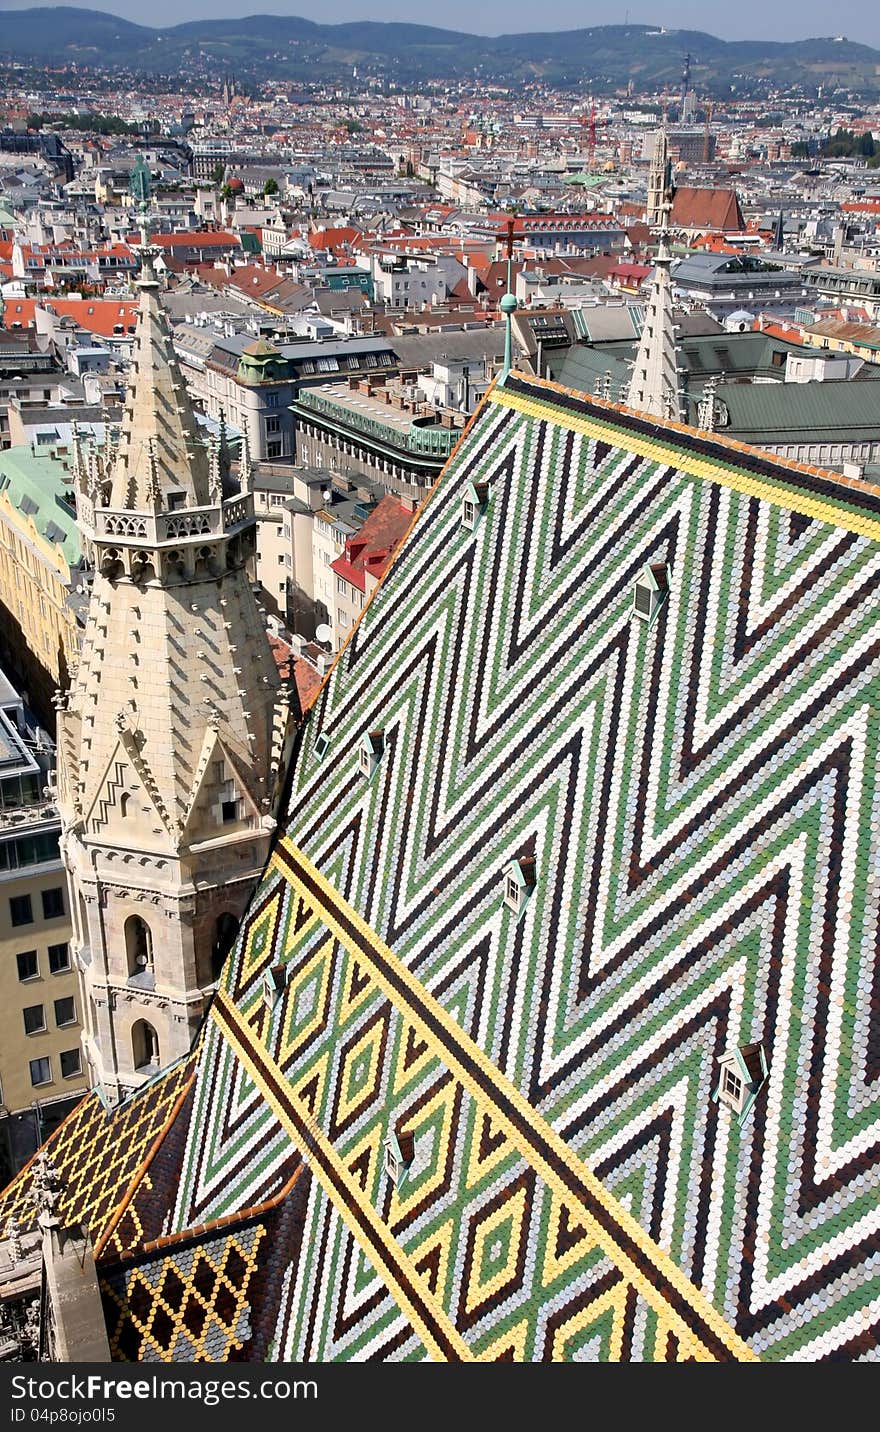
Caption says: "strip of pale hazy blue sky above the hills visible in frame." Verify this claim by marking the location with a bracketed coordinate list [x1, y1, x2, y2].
[0, 0, 880, 47]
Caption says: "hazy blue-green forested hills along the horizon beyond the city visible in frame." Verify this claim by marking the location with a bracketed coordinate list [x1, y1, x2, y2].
[0, 6, 880, 96]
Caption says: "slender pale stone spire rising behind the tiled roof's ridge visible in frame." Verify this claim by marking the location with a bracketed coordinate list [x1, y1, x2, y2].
[627, 127, 683, 420]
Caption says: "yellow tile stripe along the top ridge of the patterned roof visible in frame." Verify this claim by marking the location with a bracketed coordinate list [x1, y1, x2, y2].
[487, 384, 880, 541]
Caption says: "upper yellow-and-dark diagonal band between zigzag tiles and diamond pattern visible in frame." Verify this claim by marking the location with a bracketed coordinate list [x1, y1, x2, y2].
[272, 838, 760, 1362]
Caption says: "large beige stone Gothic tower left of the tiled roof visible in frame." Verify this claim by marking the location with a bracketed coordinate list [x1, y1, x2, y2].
[57, 251, 295, 1101]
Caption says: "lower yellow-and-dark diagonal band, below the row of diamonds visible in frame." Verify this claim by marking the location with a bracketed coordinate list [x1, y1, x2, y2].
[210, 991, 474, 1362]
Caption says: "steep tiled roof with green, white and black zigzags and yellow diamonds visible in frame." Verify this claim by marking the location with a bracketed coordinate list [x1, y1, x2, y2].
[6, 374, 880, 1362]
